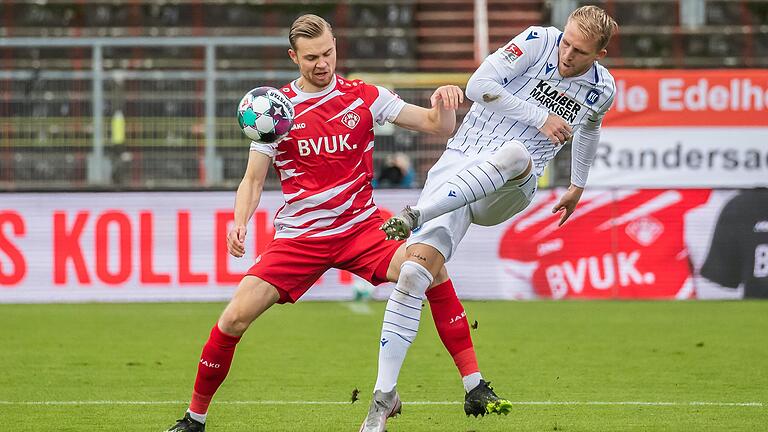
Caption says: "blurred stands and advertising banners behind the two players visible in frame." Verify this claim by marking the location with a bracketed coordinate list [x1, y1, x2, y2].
[0, 0, 768, 301]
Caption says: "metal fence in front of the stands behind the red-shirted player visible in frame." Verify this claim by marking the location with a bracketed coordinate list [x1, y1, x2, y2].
[0, 37, 524, 190]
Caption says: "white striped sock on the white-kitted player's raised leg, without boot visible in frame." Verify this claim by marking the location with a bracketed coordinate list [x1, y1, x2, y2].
[413, 161, 507, 223]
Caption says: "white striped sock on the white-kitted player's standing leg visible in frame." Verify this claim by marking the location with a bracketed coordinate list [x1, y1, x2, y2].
[373, 261, 432, 393]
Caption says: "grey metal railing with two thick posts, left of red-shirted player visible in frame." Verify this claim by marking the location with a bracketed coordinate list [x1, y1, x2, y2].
[0, 37, 295, 187]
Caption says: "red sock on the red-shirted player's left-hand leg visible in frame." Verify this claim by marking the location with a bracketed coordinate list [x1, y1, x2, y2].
[189, 324, 240, 414]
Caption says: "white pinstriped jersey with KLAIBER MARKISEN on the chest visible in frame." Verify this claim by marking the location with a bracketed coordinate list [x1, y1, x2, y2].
[448, 27, 616, 176]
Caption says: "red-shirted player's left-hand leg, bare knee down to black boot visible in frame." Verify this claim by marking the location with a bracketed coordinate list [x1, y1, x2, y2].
[168, 276, 280, 432]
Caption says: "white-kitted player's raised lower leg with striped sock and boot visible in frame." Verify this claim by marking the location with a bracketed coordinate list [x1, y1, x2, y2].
[381, 141, 532, 240]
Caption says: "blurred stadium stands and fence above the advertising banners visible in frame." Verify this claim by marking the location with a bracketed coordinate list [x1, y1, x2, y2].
[0, 0, 768, 190]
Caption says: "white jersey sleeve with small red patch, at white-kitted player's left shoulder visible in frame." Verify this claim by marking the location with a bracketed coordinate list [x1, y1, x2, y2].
[486, 26, 550, 79]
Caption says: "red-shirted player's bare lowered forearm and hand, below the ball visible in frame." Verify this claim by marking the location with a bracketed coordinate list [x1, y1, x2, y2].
[227, 151, 272, 258]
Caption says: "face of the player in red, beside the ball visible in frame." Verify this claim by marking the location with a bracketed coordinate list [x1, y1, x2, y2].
[288, 31, 336, 92]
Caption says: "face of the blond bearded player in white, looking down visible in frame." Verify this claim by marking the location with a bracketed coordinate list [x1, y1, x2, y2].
[557, 22, 607, 78]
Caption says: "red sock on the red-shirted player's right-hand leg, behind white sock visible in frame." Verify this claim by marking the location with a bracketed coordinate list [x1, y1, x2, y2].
[427, 279, 480, 377]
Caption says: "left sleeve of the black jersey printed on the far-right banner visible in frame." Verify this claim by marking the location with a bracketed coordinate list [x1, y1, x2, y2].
[701, 200, 741, 288]
